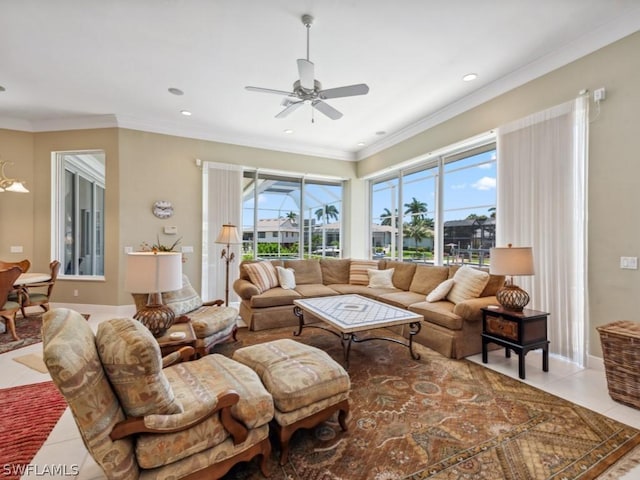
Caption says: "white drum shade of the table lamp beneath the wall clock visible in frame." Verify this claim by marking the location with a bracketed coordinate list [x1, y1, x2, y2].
[124, 252, 182, 293]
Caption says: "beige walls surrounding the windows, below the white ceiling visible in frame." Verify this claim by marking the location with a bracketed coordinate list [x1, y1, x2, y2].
[0, 33, 640, 356]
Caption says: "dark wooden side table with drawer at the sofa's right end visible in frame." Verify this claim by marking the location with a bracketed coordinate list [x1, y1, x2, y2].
[482, 307, 549, 379]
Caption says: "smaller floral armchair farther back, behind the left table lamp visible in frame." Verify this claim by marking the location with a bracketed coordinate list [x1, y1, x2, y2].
[132, 275, 238, 357]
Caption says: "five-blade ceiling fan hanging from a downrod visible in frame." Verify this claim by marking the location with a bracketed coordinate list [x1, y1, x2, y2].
[244, 15, 369, 121]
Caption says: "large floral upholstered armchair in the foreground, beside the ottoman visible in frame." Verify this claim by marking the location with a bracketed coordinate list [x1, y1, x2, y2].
[42, 309, 274, 480]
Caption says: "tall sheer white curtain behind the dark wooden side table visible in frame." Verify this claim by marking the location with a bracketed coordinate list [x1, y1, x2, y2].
[496, 97, 589, 365]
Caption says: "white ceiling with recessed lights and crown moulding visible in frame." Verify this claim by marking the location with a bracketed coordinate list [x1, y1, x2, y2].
[0, 0, 640, 160]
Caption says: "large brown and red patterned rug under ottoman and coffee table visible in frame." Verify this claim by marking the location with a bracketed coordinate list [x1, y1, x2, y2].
[215, 328, 640, 480]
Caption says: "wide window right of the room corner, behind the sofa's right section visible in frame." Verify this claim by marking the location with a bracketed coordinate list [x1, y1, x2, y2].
[370, 143, 497, 265]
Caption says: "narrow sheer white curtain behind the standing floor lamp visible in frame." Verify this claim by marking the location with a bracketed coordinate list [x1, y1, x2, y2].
[202, 162, 242, 302]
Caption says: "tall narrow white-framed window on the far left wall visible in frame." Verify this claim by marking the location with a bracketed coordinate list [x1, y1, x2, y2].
[51, 151, 105, 278]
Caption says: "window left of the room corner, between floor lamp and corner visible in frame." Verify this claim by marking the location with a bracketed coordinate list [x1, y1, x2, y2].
[242, 171, 343, 258]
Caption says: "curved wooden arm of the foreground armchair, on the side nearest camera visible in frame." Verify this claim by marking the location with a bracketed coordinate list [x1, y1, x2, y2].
[109, 390, 249, 445]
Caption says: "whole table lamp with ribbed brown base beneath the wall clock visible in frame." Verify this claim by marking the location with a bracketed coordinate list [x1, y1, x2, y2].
[124, 252, 182, 337]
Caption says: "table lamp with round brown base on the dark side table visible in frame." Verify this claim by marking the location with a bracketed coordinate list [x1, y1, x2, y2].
[489, 244, 534, 312]
